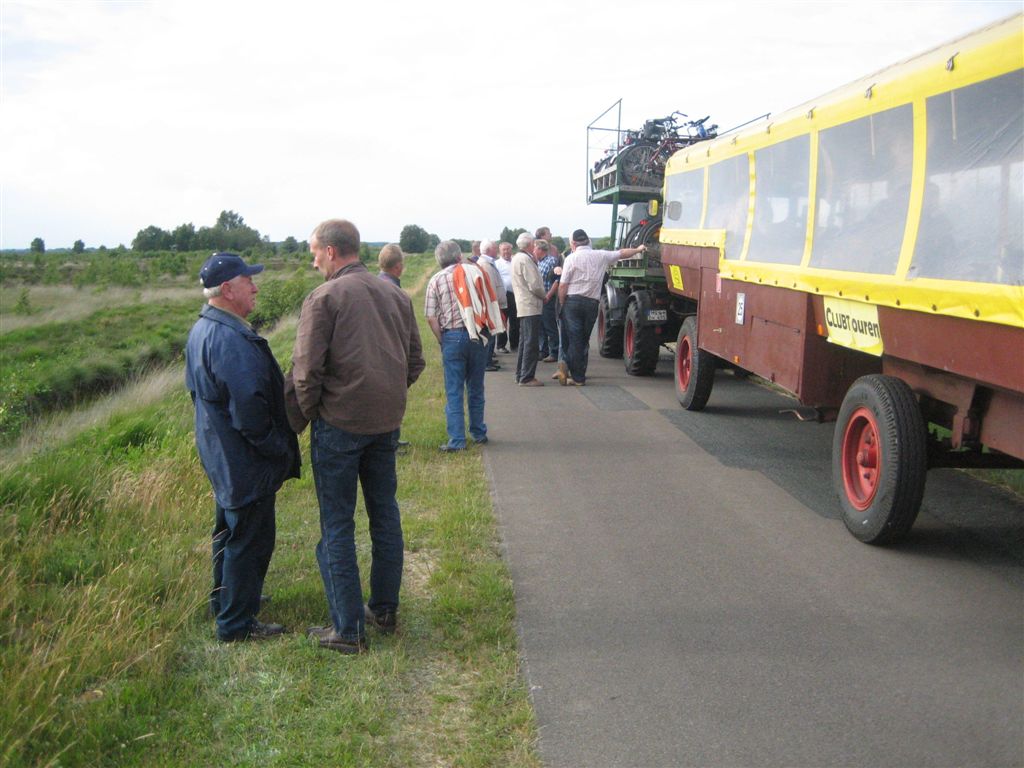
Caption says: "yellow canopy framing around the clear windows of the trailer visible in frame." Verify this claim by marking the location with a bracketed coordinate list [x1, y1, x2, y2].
[660, 14, 1024, 328]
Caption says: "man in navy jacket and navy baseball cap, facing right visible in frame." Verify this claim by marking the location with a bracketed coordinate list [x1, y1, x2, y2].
[185, 253, 299, 641]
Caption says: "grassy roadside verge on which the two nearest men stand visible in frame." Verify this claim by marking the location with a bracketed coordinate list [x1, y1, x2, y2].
[0, 257, 538, 766]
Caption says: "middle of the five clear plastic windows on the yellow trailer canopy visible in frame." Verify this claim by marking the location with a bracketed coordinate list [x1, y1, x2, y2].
[746, 134, 811, 264]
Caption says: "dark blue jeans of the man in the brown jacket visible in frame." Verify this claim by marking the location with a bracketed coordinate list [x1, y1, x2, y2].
[309, 419, 404, 640]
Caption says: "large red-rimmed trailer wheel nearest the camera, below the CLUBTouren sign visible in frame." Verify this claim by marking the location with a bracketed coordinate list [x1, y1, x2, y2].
[833, 375, 928, 544]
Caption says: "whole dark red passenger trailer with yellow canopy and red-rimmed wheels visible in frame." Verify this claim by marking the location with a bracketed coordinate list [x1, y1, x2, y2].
[659, 15, 1024, 543]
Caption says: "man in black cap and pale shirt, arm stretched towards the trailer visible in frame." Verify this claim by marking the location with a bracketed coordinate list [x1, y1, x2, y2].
[558, 229, 646, 387]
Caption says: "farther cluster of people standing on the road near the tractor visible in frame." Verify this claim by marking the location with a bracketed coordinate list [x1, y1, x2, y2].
[426, 226, 644, 453]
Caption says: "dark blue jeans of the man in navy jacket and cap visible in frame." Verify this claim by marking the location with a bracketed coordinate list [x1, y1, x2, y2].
[210, 494, 276, 640]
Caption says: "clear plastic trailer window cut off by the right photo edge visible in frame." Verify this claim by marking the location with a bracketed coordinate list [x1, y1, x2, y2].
[907, 70, 1024, 286]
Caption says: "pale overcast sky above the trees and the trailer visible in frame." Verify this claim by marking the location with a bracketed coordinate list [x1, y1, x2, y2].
[0, 0, 1024, 248]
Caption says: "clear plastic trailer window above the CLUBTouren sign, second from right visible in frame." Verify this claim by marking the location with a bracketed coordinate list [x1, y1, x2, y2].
[811, 104, 913, 274]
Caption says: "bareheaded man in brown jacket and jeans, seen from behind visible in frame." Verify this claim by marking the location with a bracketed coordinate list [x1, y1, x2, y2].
[290, 219, 425, 653]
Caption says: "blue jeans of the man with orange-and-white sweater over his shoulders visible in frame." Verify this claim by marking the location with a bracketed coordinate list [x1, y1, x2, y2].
[441, 328, 487, 449]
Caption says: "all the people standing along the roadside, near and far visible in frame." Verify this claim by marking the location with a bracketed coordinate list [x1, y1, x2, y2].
[185, 219, 642, 653]
